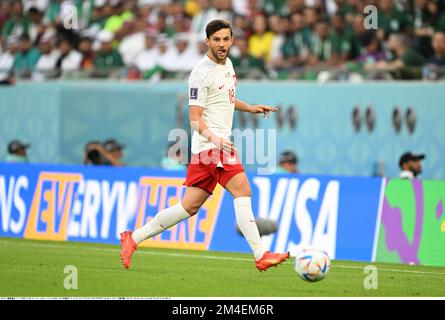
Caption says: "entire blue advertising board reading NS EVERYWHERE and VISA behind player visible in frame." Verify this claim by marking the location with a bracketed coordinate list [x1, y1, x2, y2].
[0, 164, 383, 261]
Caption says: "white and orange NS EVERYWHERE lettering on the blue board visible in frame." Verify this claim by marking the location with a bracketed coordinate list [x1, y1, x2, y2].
[0, 166, 223, 250]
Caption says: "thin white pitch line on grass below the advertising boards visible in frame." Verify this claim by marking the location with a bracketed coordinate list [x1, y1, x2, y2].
[0, 240, 445, 277]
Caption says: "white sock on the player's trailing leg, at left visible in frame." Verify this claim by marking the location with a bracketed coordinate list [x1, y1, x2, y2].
[133, 202, 190, 244]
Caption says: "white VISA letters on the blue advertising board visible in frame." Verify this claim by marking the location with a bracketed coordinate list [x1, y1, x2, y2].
[253, 177, 340, 257]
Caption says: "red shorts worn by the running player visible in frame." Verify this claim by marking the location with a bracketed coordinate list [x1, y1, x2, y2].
[184, 149, 244, 194]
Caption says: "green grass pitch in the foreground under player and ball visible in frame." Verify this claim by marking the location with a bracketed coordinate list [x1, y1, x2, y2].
[0, 238, 445, 297]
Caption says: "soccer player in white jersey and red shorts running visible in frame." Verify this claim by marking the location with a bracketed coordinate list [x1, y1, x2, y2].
[121, 20, 289, 271]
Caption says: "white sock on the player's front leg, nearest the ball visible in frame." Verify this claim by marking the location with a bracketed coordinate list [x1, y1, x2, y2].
[233, 197, 265, 260]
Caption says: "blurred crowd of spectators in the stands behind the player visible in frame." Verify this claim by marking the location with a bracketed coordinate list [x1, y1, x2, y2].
[0, 0, 445, 83]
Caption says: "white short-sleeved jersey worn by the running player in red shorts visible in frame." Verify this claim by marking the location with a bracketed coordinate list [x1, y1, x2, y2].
[189, 55, 236, 154]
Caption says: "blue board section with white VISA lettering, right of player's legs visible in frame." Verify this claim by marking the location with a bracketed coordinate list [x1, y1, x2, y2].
[246, 175, 383, 261]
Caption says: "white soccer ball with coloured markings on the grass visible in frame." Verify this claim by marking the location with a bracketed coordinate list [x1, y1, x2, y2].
[294, 248, 331, 282]
